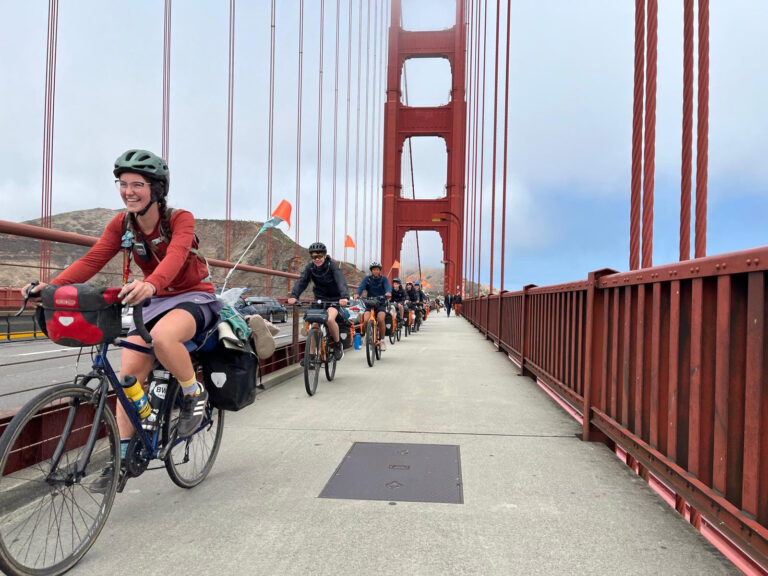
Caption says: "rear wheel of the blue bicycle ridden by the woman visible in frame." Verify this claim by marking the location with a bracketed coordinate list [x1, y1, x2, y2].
[163, 381, 224, 488]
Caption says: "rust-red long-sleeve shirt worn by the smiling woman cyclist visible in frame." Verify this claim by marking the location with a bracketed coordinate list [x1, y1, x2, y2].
[51, 210, 214, 296]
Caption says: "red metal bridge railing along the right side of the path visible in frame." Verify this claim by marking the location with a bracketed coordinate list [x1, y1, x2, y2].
[462, 247, 768, 570]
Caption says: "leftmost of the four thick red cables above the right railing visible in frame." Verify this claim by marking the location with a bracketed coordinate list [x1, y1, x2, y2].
[629, 0, 647, 270]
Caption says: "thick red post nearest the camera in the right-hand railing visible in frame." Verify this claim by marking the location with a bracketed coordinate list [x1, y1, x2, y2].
[581, 268, 616, 442]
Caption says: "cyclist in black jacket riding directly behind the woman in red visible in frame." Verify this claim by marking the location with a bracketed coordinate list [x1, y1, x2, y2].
[288, 242, 349, 360]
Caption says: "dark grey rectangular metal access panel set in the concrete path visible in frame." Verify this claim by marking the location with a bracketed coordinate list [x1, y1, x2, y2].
[320, 442, 464, 504]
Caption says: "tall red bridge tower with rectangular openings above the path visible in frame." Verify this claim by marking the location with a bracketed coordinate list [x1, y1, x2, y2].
[381, 0, 467, 290]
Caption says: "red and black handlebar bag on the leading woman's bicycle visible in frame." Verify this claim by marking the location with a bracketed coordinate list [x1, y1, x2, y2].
[35, 284, 122, 347]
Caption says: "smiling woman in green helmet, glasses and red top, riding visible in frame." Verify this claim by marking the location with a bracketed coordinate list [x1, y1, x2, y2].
[22, 150, 221, 457]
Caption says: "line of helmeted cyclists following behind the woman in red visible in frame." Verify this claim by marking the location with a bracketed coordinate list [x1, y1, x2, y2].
[288, 242, 428, 360]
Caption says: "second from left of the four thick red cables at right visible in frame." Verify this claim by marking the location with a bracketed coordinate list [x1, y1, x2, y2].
[642, 0, 659, 268]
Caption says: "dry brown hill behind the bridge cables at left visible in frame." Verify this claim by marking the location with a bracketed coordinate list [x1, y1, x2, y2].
[0, 208, 364, 297]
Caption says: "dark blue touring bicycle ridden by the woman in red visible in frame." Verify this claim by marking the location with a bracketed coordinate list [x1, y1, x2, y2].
[0, 288, 224, 575]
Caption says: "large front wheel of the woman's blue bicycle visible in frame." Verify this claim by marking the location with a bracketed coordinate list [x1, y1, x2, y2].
[0, 384, 120, 574]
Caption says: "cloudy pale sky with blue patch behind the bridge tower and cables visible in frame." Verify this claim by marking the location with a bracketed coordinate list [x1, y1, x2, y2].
[0, 0, 768, 290]
